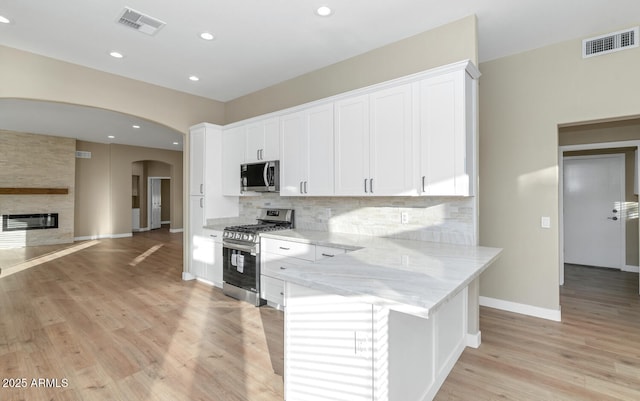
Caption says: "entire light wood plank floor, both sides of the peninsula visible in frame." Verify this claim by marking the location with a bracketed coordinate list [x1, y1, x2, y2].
[0, 230, 640, 401]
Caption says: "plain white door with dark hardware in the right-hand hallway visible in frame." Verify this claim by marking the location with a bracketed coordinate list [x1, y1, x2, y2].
[563, 155, 625, 269]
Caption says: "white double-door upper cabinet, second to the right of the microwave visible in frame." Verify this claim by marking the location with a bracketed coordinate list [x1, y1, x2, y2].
[335, 84, 417, 196]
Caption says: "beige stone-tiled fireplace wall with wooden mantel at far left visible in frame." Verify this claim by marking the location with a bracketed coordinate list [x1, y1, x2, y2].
[0, 130, 76, 248]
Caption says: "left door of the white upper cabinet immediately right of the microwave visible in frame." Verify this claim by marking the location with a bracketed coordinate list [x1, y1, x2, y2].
[280, 112, 307, 196]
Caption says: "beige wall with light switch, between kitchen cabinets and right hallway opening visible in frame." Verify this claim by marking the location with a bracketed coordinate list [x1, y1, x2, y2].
[480, 27, 640, 310]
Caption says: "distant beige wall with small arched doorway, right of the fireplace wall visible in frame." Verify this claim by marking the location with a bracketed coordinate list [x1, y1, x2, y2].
[75, 141, 183, 238]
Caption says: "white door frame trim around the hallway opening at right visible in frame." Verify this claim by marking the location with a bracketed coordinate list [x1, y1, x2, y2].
[558, 140, 640, 286]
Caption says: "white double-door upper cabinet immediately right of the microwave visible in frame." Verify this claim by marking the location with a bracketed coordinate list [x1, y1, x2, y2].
[280, 103, 333, 196]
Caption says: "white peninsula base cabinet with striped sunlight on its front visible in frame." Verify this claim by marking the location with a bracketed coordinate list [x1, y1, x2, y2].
[284, 282, 468, 401]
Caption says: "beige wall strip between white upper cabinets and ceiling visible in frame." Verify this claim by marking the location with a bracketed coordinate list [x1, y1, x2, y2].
[222, 16, 478, 124]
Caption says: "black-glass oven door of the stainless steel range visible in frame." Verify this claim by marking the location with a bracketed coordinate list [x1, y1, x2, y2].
[222, 241, 260, 296]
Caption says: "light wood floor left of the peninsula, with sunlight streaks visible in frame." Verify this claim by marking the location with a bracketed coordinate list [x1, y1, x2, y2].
[0, 230, 283, 401]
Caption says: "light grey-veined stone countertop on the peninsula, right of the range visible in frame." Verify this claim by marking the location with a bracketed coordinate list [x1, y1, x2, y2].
[261, 230, 502, 318]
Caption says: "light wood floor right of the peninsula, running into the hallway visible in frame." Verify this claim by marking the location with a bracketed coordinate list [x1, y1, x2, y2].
[436, 265, 640, 401]
